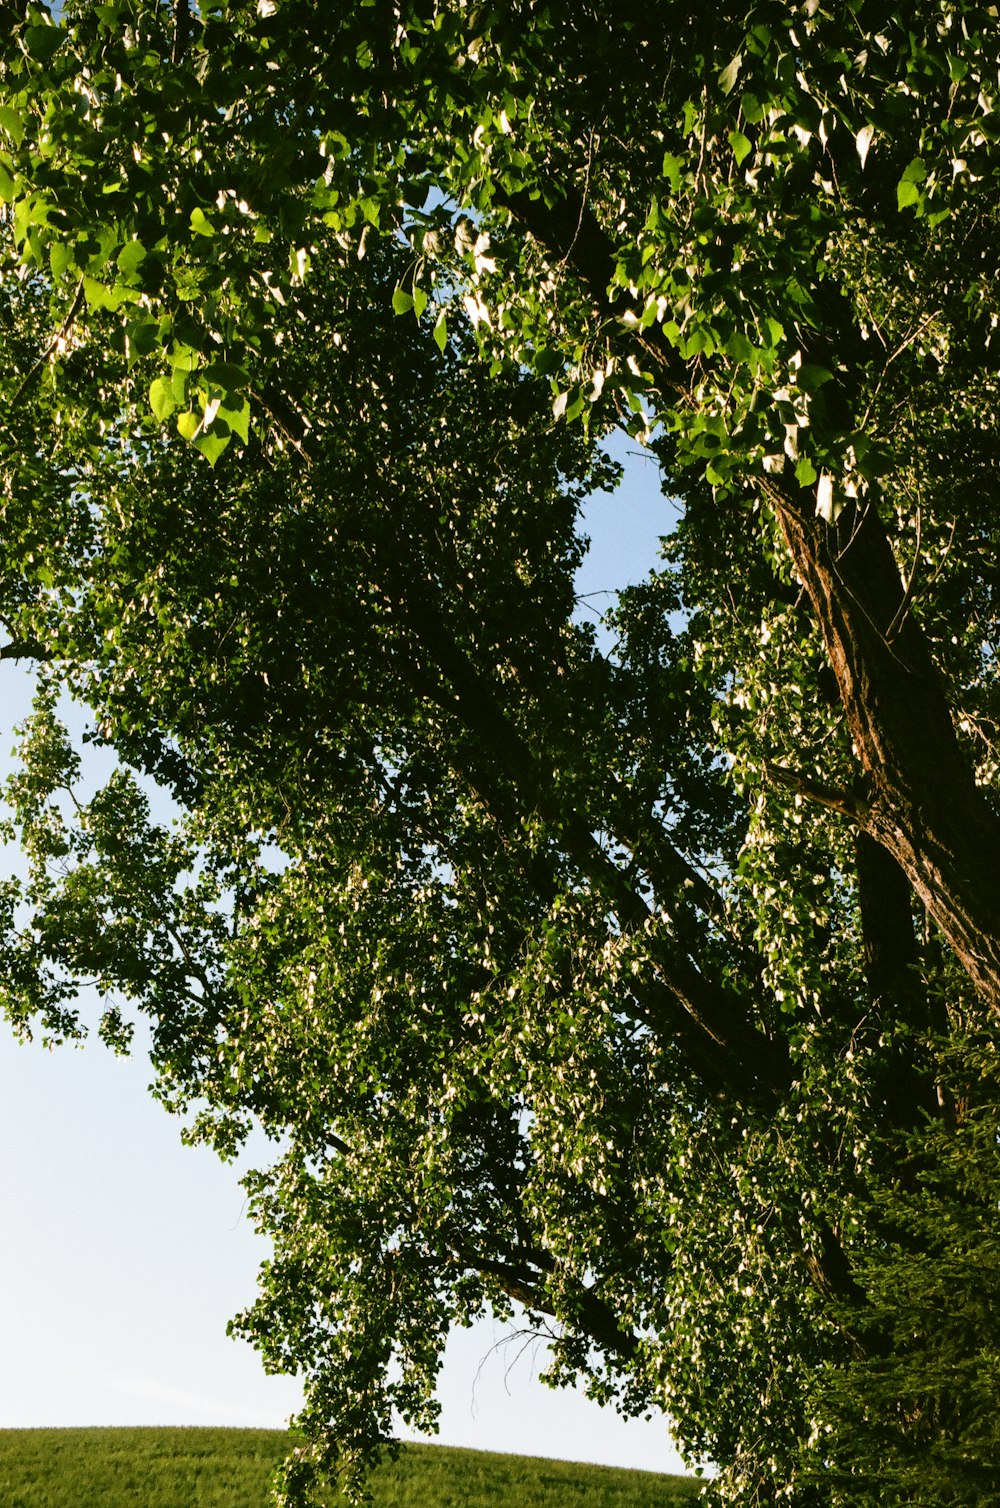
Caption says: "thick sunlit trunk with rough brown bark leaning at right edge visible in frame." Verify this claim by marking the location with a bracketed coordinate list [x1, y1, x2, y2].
[766, 483, 1000, 1009]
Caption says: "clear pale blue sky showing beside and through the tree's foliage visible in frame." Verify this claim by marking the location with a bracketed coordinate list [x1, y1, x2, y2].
[0, 440, 682, 1470]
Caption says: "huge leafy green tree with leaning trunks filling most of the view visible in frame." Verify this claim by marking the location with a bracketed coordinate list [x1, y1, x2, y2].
[0, 0, 1000, 1505]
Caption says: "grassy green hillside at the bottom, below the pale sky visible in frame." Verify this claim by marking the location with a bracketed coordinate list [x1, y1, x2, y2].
[0, 1430, 697, 1508]
